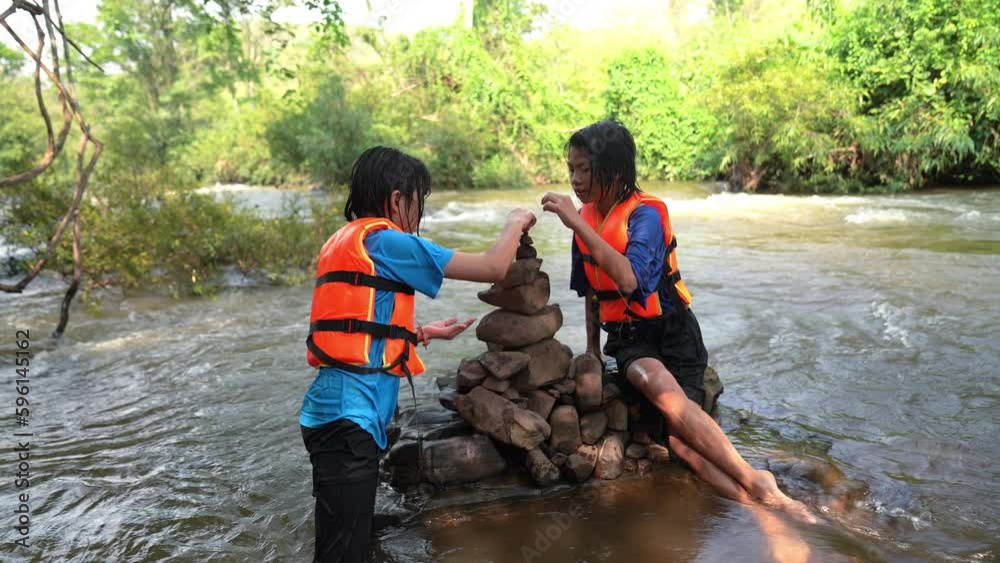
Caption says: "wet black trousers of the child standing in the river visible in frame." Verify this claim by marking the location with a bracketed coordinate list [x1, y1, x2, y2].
[301, 419, 380, 563]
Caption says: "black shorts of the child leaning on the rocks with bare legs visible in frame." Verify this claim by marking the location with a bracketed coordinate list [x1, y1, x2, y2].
[604, 308, 708, 438]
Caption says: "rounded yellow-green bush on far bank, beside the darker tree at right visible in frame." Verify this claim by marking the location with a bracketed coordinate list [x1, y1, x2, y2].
[707, 42, 858, 191]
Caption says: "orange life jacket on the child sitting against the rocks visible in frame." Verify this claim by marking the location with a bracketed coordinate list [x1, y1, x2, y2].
[576, 192, 691, 323]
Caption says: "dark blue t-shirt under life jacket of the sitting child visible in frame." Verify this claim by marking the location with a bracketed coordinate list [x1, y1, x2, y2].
[569, 205, 674, 314]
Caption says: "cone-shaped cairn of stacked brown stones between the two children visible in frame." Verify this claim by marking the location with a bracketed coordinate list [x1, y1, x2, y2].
[400, 235, 668, 486]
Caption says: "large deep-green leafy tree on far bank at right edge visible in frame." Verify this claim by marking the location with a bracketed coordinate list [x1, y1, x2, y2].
[832, 0, 1000, 189]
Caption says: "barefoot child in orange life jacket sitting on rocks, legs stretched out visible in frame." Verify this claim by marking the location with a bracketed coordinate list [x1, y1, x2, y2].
[542, 121, 812, 520]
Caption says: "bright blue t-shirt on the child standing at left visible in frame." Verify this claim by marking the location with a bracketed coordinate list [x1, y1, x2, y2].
[299, 230, 455, 449]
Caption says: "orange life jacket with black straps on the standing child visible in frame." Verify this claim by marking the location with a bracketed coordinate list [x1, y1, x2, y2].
[306, 218, 424, 376]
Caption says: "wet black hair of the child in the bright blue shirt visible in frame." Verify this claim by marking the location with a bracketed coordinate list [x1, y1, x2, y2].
[344, 147, 431, 234]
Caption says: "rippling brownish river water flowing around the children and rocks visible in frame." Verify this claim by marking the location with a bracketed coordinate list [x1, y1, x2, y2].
[0, 184, 1000, 562]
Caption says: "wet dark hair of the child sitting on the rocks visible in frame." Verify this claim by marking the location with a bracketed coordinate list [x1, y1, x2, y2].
[566, 119, 642, 201]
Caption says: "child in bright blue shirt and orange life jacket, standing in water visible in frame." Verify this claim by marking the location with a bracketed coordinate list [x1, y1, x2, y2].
[299, 147, 535, 562]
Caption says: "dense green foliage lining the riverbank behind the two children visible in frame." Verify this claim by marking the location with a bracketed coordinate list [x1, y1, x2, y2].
[0, 0, 1000, 294]
